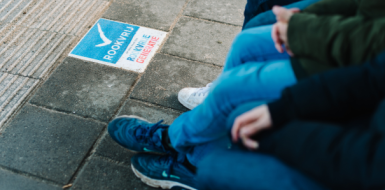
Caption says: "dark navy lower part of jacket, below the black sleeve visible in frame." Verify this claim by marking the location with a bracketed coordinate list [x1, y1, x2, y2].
[259, 119, 385, 190]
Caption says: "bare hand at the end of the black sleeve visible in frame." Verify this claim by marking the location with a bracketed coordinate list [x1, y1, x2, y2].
[231, 105, 271, 150]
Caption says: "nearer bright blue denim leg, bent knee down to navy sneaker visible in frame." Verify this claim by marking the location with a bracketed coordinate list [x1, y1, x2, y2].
[168, 60, 296, 165]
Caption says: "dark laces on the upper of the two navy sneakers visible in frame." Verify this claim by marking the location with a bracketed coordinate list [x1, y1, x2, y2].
[134, 120, 168, 150]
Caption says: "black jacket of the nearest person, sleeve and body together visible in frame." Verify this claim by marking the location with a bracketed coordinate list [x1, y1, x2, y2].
[258, 53, 385, 190]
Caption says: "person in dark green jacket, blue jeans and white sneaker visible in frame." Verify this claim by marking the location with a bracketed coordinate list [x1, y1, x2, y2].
[178, 0, 385, 109]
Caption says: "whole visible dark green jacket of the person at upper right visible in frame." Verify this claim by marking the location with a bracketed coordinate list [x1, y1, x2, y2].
[288, 0, 385, 78]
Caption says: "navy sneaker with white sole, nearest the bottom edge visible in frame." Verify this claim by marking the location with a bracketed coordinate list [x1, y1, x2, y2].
[131, 154, 196, 190]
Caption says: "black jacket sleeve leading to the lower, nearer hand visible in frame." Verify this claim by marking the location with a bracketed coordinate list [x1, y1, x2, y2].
[268, 52, 385, 126]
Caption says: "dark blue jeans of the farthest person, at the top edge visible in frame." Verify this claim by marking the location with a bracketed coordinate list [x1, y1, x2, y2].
[243, 0, 319, 29]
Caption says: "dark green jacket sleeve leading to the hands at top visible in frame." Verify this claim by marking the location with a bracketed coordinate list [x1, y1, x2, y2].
[288, 13, 385, 67]
